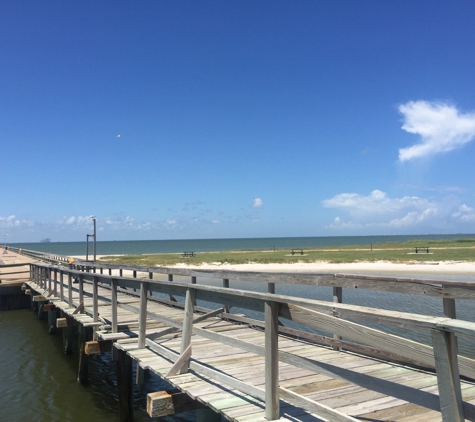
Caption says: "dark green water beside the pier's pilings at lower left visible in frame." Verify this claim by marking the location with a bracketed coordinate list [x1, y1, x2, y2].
[0, 310, 194, 422]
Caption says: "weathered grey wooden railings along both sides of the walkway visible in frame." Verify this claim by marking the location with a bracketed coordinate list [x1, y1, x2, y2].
[31, 264, 475, 421]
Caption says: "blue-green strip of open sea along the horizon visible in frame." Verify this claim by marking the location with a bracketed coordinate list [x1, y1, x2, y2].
[11, 234, 475, 255]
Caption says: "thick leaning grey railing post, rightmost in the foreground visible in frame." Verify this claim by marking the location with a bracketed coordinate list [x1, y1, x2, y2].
[432, 330, 465, 422]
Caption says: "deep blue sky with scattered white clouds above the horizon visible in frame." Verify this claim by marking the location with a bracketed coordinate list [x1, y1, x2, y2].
[0, 0, 475, 242]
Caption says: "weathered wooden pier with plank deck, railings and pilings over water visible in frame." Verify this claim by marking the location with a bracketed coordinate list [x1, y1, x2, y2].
[2, 250, 475, 422]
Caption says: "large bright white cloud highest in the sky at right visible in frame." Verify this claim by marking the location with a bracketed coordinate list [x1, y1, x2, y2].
[399, 101, 475, 162]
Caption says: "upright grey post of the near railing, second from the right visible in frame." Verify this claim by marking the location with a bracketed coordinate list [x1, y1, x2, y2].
[264, 300, 280, 421]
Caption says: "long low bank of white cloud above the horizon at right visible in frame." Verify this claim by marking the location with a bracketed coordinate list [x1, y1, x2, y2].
[322, 190, 475, 230]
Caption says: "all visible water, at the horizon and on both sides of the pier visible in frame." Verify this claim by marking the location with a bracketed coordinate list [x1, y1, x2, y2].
[0, 235, 475, 422]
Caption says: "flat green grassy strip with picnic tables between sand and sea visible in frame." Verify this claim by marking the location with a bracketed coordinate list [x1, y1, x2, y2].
[101, 239, 475, 266]
